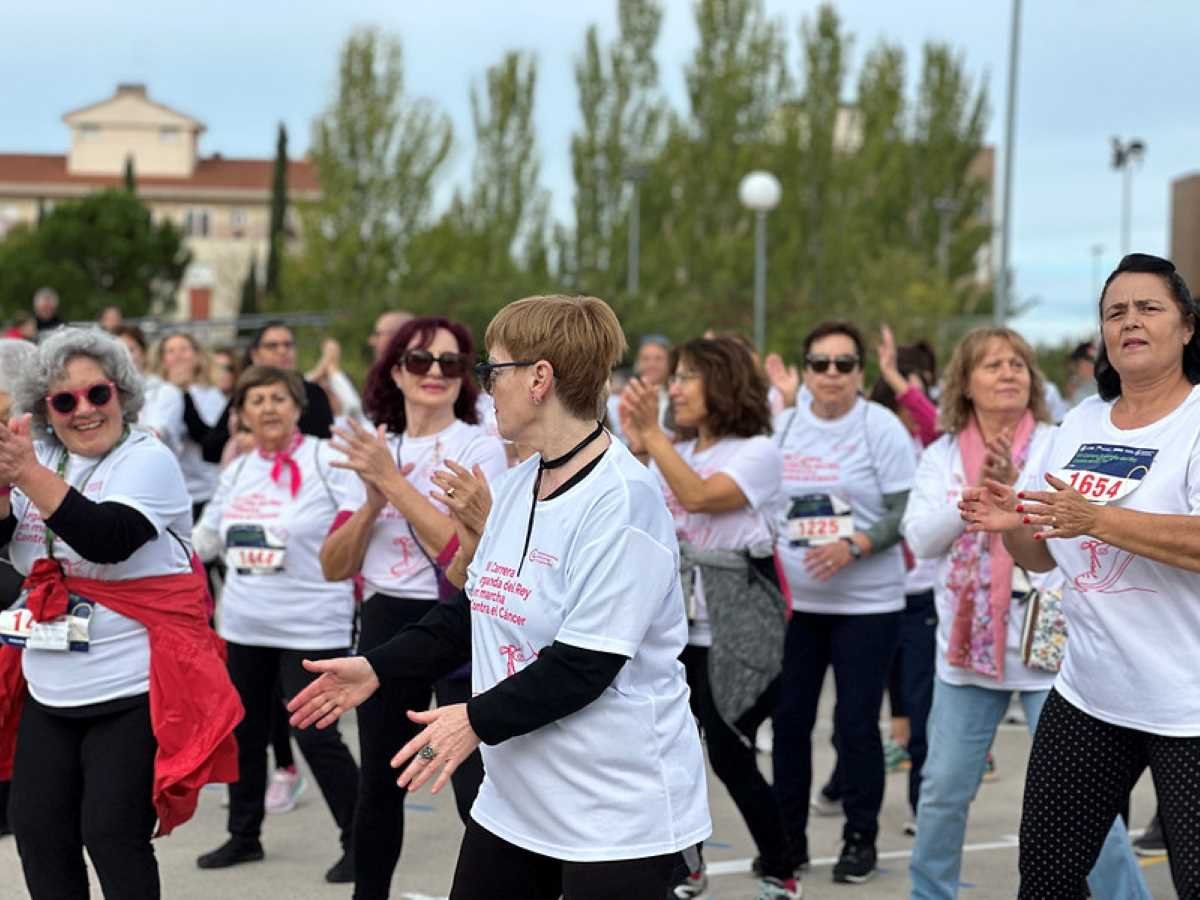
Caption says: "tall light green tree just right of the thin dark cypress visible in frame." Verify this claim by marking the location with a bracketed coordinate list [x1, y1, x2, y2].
[283, 29, 451, 318]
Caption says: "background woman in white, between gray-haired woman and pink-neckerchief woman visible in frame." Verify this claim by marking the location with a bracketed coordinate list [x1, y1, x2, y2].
[157, 331, 226, 521]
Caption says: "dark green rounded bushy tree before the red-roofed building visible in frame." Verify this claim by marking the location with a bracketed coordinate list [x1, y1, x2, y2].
[0, 188, 191, 319]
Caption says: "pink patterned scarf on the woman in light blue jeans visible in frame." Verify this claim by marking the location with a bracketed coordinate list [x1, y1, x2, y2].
[946, 410, 1037, 682]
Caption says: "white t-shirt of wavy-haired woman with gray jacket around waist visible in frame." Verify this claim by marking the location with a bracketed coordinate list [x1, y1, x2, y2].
[650, 436, 781, 647]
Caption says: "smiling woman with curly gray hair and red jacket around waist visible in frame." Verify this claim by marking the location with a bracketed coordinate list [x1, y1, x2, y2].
[0, 329, 241, 900]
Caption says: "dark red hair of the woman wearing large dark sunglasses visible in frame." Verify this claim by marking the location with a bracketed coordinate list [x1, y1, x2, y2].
[362, 316, 479, 434]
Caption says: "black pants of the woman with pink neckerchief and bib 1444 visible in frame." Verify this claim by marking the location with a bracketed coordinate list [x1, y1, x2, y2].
[228, 641, 359, 848]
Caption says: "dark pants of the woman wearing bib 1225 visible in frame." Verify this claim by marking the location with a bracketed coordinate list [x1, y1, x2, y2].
[773, 612, 901, 856]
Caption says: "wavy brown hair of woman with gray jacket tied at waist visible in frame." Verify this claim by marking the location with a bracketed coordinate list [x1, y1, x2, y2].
[671, 337, 770, 438]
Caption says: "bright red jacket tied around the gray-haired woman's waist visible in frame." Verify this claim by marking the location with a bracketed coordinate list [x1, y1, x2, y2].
[0, 559, 242, 836]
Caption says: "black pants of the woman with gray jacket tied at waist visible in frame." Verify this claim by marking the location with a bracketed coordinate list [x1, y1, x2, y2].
[679, 644, 792, 878]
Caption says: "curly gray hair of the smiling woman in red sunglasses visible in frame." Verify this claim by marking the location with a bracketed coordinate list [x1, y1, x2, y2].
[12, 328, 145, 440]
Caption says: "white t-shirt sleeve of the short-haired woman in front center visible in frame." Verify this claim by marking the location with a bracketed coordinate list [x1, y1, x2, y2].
[554, 516, 678, 659]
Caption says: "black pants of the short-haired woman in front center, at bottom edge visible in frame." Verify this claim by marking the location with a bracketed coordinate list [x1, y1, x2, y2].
[450, 820, 677, 900]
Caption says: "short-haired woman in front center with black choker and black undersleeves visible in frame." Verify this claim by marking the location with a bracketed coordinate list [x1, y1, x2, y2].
[290, 296, 712, 900]
